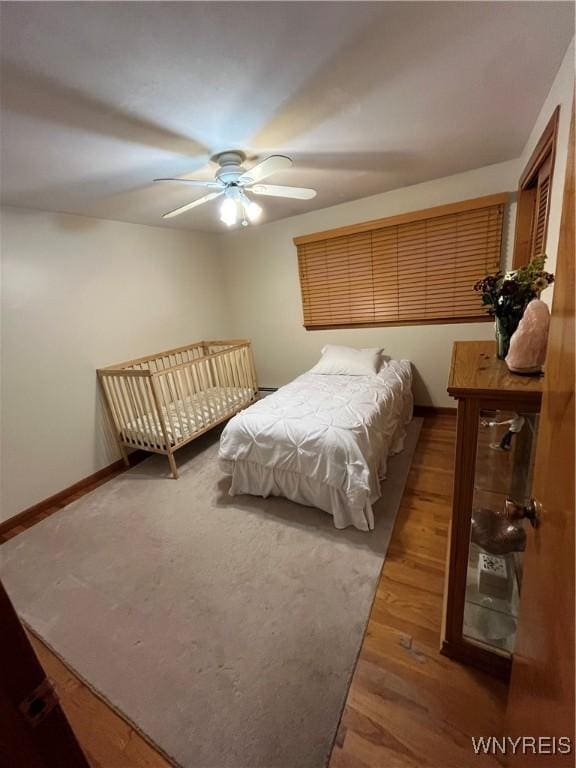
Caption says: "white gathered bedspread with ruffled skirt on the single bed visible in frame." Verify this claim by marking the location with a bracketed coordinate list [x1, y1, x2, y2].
[219, 360, 412, 530]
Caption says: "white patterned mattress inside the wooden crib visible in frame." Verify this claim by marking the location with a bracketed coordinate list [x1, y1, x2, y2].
[122, 387, 254, 446]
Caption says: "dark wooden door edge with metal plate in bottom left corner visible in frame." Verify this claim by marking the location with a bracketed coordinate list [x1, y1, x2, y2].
[0, 583, 89, 768]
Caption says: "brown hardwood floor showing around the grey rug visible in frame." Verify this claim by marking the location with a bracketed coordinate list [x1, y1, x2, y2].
[2, 415, 506, 768]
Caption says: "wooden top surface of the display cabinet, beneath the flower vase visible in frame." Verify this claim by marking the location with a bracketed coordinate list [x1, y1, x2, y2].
[448, 341, 543, 403]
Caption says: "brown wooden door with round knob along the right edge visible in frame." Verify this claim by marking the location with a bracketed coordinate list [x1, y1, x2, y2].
[503, 100, 576, 768]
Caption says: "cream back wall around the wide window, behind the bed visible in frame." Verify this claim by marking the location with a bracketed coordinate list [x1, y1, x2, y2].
[219, 161, 519, 406]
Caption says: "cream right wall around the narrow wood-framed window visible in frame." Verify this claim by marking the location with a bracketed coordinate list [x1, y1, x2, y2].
[519, 40, 574, 284]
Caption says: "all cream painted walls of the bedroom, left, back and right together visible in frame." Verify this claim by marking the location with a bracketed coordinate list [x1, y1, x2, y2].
[0, 41, 574, 520]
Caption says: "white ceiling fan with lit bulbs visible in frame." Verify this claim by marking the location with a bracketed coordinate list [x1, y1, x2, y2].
[154, 151, 316, 227]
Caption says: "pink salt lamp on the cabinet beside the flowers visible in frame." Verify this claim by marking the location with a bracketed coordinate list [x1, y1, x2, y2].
[506, 299, 550, 374]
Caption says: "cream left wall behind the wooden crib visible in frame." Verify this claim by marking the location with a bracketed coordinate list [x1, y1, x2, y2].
[0, 208, 229, 519]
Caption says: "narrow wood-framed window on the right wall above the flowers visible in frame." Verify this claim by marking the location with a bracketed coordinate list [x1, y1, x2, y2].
[512, 107, 560, 268]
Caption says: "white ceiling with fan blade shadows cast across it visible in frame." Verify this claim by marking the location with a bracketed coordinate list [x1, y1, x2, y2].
[1, 2, 574, 231]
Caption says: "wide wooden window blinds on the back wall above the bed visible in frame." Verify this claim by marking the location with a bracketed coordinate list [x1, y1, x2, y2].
[294, 194, 507, 329]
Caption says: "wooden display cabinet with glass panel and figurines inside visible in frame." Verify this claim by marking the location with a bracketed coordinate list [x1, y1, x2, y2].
[441, 341, 542, 677]
